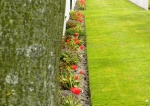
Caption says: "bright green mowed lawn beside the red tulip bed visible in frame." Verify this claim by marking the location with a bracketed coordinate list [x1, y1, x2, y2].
[84, 0, 150, 106]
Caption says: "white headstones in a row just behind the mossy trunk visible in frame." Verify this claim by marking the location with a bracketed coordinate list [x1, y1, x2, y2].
[63, 0, 77, 34]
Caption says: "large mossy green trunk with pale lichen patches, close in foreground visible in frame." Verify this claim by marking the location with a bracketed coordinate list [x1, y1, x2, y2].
[0, 0, 65, 106]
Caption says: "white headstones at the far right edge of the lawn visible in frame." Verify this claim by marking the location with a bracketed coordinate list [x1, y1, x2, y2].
[129, 0, 149, 10]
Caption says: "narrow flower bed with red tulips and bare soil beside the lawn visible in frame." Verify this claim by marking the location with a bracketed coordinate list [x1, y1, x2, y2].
[59, 0, 91, 106]
